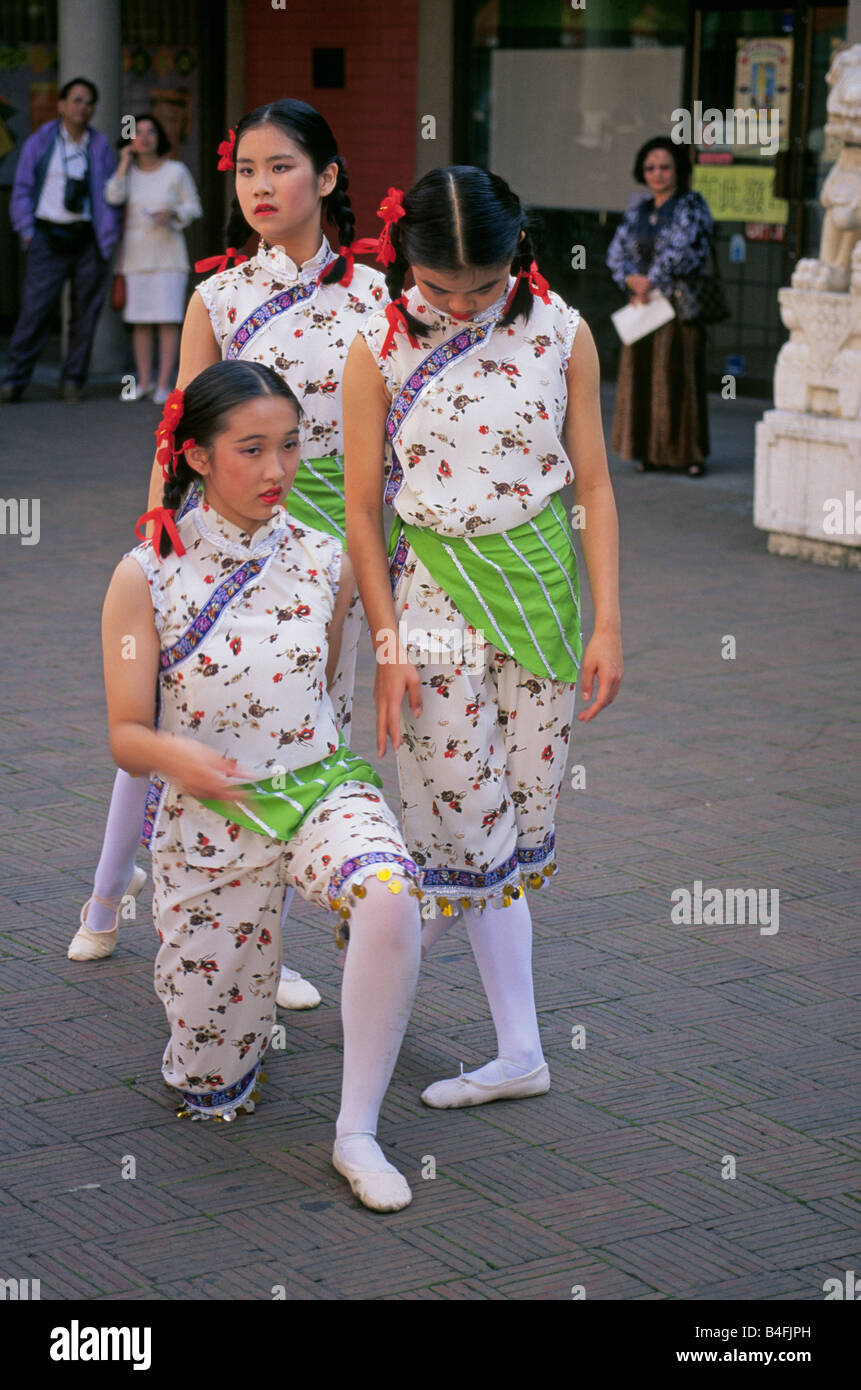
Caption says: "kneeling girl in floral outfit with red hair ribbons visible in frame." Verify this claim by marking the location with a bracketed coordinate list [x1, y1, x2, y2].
[102, 361, 420, 1211]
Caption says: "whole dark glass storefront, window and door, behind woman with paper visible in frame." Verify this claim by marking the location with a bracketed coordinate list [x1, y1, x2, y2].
[458, 0, 846, 395]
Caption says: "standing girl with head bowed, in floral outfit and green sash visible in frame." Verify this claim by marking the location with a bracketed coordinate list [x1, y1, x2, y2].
[344, 165, 622, 1109]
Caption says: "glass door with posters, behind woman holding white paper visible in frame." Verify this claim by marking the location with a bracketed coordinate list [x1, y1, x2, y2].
[689, 0, 847, 395]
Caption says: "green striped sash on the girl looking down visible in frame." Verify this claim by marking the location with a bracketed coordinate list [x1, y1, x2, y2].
[388, 493, 581, 681]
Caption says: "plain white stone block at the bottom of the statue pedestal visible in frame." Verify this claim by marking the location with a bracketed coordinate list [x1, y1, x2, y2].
[754, 410, 861, 556]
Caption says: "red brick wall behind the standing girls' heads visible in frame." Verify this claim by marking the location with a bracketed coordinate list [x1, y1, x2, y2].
[244, 0, 417, 236]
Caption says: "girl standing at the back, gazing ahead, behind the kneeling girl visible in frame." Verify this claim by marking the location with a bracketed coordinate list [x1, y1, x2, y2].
[70, 99, 387, 1009]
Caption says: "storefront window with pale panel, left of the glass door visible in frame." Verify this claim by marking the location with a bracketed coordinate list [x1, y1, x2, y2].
[459, 0, 687, 370]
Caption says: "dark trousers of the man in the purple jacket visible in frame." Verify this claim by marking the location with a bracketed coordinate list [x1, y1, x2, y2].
[4, 222, 110, 386]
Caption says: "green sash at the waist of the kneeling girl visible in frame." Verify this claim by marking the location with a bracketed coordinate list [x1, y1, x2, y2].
[200, 737, 383, 840]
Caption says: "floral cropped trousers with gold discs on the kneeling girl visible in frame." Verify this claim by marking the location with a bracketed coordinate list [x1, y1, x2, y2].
[153, 781, 417, 1111]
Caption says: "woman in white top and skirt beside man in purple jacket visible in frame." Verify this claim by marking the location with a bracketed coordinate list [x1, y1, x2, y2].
[104, 115, 203, 404]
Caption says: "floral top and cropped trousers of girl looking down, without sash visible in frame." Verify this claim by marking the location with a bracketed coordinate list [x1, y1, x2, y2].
[360, 277, 580, 916]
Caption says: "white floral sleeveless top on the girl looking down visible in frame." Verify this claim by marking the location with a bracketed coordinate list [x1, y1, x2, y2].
[353, 277, 580, 537]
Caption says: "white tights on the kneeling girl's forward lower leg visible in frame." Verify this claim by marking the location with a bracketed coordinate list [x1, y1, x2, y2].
[335, 870, 421, 1169]
